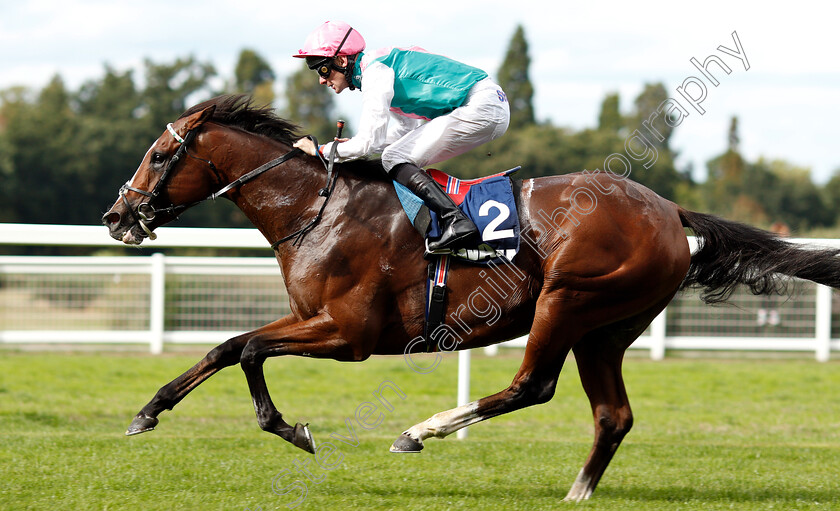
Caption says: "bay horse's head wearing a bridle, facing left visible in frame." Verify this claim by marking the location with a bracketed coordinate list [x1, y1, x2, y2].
[102, 106, 215, 245]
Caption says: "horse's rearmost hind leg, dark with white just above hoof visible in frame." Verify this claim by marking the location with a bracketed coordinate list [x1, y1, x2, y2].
[565, 338, 633, 502]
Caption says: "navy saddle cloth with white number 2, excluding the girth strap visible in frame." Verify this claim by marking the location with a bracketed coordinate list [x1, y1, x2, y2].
[394, 167, 521, 264]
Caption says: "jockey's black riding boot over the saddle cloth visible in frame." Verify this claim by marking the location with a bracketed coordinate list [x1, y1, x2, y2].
[391, 163, 481, 252]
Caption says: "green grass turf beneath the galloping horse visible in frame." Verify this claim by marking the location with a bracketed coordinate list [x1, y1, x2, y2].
[0, 350, 840, 511]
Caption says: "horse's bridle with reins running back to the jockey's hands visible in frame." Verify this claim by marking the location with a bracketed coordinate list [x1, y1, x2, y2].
[119, 121, 344, 249]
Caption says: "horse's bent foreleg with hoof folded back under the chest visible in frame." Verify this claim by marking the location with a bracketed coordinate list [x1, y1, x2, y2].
[240, 314, 352, 453]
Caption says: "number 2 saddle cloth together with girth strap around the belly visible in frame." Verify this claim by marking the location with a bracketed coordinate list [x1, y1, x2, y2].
[394, 167, 521, 352]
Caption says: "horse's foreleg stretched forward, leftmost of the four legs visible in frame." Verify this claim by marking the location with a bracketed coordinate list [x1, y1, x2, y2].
[125, 315, 295, 435]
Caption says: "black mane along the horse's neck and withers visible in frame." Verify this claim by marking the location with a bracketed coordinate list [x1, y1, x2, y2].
[181, 94, 387, 180]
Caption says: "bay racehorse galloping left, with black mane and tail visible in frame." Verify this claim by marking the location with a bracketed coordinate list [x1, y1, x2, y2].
[103, 96, 840, 500]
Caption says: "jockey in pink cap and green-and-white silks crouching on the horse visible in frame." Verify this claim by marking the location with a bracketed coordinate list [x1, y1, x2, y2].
[294, 21, 510, 252]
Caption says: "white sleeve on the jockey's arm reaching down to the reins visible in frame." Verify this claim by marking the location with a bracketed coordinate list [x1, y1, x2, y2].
[323, 62, 394, 161]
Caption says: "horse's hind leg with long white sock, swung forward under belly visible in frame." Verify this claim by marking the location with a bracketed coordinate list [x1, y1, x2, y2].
[391, 298, 577, 452]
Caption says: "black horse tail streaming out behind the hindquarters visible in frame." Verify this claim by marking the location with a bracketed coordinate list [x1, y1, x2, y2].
[679, 208, 840, 303]
